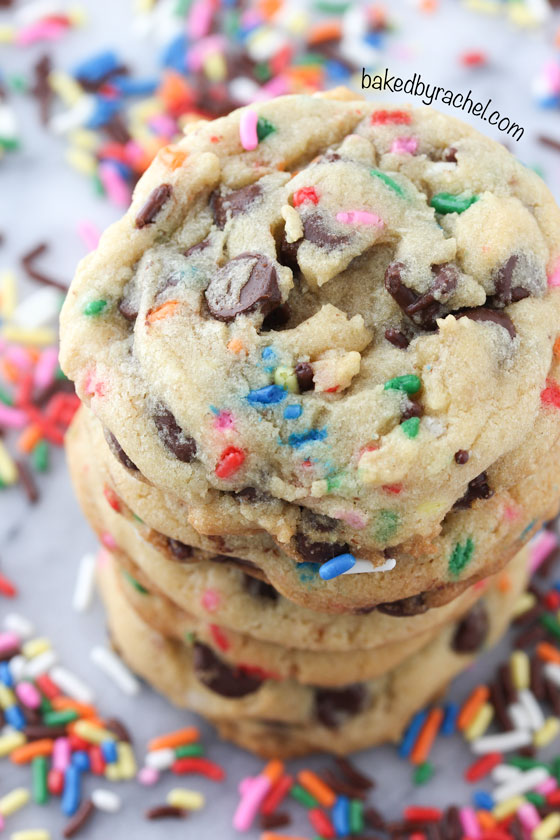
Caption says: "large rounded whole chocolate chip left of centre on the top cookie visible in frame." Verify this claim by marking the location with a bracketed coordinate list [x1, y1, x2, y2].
[205, 252, 282, 321]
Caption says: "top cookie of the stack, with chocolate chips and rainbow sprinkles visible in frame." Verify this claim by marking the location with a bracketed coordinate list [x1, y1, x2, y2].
[61, 91, 560, 559]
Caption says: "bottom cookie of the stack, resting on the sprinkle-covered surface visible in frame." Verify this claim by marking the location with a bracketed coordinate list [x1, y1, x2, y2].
[99, 551, 527, 758]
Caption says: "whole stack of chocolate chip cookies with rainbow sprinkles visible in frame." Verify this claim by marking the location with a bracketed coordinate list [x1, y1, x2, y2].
[61, 90, 560, 756]
